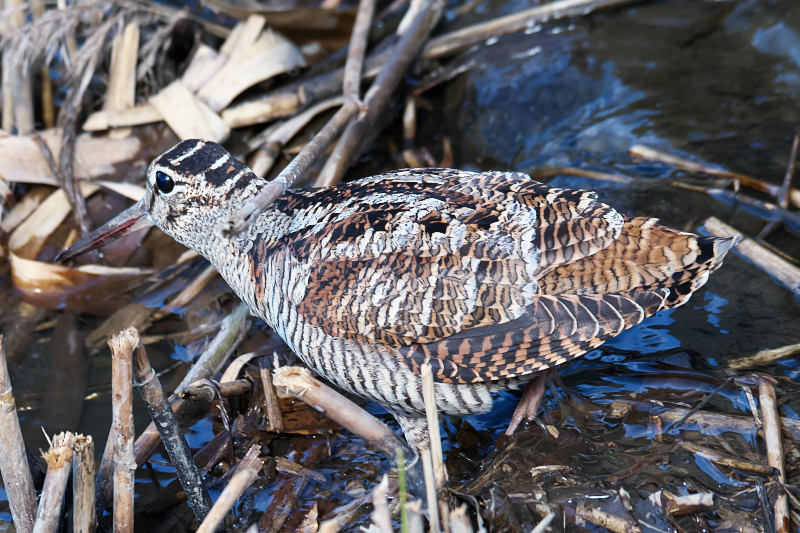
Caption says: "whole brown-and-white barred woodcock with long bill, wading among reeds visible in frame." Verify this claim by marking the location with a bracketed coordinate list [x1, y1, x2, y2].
[60, 140, 736, 448]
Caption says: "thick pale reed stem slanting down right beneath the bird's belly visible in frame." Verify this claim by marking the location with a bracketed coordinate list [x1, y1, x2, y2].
[273, 366, 423, 492]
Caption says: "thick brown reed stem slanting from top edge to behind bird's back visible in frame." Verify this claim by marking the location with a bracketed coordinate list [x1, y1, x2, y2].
[314, 0, 443, 187]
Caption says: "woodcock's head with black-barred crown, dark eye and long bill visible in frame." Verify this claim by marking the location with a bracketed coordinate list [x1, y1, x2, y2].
[56, 139, 265, 262]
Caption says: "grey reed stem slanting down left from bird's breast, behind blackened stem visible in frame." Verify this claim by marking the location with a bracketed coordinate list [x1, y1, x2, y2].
[133, 303, 249, 466]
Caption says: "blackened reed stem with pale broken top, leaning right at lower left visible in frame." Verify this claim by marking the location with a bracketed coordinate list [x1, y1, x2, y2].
[126, 328, 211, 524]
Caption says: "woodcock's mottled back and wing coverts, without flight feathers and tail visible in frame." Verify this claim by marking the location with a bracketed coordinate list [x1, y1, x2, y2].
[281, 169, 622, 354]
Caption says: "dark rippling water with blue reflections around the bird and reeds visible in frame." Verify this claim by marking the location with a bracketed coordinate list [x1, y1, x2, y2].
[0, 0, 800, 531]
